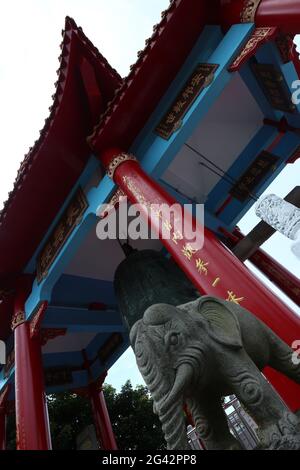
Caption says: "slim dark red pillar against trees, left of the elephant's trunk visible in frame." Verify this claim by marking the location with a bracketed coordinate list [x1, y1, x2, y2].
[89, 383, 118, 450]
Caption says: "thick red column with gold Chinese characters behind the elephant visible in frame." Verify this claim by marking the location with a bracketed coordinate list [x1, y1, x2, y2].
[101, 149, 300, 409]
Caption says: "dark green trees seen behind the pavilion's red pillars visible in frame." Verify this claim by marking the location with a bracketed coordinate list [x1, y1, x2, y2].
[8, 381, 165, 450]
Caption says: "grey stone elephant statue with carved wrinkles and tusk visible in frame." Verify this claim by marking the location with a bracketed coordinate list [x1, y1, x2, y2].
[130, 296, 300, 450]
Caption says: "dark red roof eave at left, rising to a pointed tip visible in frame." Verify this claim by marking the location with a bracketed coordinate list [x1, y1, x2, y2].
[0, 18, 122, 287]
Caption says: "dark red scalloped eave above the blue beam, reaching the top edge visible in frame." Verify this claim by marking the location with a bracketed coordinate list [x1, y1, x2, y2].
[89, 0, 211, 153]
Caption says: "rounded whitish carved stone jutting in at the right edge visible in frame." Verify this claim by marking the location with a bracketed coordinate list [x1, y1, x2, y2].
[255, 194, 300, 240]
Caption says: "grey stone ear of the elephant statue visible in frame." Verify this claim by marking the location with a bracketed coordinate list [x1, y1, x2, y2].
[199, 297, 243, 348]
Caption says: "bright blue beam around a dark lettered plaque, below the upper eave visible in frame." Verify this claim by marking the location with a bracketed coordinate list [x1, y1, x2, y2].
[133, 24, 254, 178]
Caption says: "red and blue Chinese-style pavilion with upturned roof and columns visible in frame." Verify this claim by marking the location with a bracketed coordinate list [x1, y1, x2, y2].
[0, 0, 300, 449]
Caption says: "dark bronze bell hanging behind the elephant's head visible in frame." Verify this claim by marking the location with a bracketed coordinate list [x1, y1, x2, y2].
[114, 247, 200, 329]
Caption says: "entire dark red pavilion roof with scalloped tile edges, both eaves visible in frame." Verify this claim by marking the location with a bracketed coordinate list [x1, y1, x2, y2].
[0, 0, 300, 302]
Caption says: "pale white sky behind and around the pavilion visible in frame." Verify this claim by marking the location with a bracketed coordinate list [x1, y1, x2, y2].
[0, 0, 300, 388]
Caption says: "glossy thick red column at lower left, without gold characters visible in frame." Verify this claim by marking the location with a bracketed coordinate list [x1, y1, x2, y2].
[12, 285, 51, 450]
